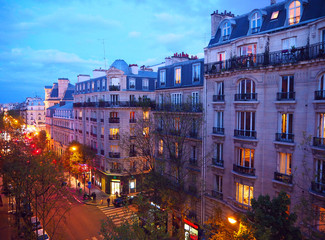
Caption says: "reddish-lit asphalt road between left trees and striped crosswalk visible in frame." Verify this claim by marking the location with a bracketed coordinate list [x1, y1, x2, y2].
[50, 203, 106, 240]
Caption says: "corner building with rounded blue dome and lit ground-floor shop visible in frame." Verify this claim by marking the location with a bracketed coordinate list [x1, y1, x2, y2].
[73, 60, 157, 194]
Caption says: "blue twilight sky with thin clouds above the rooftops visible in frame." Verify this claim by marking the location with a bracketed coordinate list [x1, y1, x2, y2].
[0, 0, 270, 103]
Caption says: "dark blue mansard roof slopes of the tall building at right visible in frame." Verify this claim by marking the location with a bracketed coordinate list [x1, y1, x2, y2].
[208, 0, 325, 48]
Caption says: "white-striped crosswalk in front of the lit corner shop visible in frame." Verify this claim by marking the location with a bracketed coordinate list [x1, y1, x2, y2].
[97, 206, 136, 226]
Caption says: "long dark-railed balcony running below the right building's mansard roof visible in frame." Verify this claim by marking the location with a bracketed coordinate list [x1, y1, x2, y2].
[204, 42, 325, 75]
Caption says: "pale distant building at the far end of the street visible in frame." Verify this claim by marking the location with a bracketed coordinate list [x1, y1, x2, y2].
[20, 97, 45, 131]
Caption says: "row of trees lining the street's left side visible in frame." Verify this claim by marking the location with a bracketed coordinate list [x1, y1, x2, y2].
[0, 115, 72, 239]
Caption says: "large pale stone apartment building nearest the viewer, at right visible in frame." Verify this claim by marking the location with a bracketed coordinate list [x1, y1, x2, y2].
[204, 0, 325, 231]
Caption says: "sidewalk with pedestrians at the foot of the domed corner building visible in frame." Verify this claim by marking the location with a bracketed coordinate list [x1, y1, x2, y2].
[68, 176, 111, 206]
